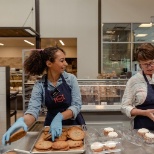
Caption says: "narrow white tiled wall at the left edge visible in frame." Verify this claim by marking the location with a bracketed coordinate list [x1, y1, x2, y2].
[0, 67, 6, 143]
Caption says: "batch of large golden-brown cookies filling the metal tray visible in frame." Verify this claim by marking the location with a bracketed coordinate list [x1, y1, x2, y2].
[33, 126, 85, 153]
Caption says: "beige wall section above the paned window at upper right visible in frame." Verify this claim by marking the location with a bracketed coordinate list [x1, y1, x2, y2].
[102, 0, 154, 23]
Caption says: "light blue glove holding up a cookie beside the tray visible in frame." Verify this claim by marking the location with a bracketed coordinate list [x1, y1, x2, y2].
[2, 117, 28, 145]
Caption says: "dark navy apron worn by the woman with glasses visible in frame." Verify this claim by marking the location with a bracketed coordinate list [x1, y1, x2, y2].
[134, 72, 154, 130]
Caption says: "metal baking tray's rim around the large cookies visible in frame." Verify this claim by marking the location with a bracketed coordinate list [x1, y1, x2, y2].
[30, 125, 85, 154]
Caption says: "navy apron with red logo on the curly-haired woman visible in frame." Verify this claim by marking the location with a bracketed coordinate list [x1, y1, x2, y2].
[44, 75, 85, 126]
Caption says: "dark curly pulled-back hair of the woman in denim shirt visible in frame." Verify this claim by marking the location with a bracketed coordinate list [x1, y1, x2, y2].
[24, 46, 65, 75]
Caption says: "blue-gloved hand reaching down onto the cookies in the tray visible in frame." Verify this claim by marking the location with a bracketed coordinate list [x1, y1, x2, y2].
[49, 112, 63, 141]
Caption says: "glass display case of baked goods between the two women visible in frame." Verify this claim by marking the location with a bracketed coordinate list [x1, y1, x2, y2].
[78, 79, 127, 110]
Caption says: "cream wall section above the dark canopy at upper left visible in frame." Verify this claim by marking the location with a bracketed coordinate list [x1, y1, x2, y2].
[0, 0, 35, 29]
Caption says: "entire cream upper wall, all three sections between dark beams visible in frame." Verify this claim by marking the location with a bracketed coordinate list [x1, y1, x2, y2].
[0, 0, 154, 78]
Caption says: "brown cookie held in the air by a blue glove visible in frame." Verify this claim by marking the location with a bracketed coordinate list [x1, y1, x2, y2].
[7, 129, 27, 143]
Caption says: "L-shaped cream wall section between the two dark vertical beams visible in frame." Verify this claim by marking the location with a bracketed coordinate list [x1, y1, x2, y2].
[40, 0, 98, 78]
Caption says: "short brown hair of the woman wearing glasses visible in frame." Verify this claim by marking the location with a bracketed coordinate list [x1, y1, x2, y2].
[136, 43, 154, 62]
